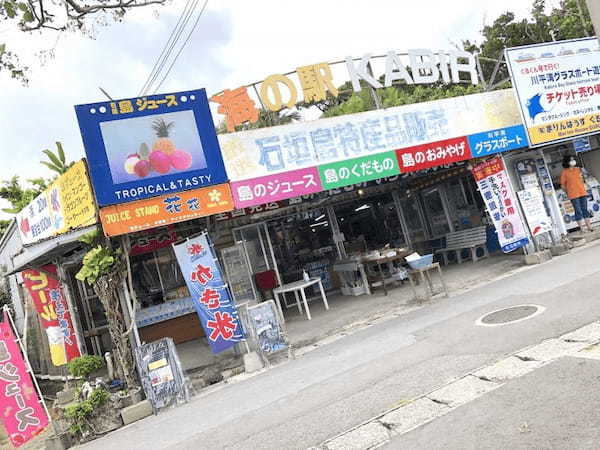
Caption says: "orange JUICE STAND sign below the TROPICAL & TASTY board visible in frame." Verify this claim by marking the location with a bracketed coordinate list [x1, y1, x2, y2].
[100, 184, 233, 236]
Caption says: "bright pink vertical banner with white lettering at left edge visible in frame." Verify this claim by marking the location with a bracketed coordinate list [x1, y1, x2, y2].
[0, 311, 48, 447]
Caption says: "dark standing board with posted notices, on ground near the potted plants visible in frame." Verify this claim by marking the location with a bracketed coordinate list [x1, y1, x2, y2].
[135, 337, 190, 411]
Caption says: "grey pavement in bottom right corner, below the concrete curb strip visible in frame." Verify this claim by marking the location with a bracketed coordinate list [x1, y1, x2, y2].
[385, 357, 600, 450]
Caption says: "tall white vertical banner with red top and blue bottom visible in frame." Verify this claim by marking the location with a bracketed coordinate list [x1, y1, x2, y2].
[473, 158, 529, 253]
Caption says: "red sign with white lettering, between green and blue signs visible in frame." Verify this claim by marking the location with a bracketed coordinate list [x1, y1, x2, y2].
[396, 137, 472, 173]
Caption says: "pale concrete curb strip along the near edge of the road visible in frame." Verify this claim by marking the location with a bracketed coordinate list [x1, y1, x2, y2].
[310, 321, 600, 450]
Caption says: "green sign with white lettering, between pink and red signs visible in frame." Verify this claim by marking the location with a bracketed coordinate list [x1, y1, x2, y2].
[319, 152, 400, 190]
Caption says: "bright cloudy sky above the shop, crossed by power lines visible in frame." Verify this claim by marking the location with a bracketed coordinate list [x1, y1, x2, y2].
[0, 0, 556, 217]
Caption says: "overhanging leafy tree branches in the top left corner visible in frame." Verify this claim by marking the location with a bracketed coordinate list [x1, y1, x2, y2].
[0, 0, 167, 83]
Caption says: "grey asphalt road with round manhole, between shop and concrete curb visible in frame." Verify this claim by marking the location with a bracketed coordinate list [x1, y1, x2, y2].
[78, 246, 600, 450]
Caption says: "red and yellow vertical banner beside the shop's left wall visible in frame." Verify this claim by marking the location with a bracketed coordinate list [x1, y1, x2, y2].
[22, 264, 81, 367]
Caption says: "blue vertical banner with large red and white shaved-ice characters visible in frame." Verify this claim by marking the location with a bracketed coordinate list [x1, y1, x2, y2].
[173, 233, 244, 353]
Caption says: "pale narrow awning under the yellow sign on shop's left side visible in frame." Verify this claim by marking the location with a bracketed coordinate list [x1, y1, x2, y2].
[7, 225, 97, 275]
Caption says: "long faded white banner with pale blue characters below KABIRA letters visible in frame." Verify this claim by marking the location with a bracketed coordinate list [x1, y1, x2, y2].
[219, 89, 521, 182]
